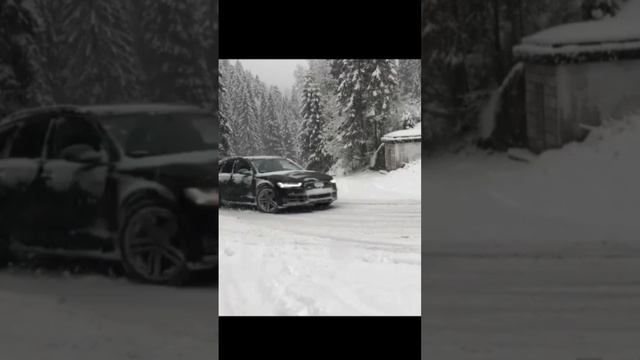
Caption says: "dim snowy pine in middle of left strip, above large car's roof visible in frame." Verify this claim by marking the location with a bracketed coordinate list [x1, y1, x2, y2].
[63, 0, 140, 104]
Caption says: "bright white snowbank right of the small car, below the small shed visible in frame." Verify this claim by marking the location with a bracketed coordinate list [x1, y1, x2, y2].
[336, 160, 422, 201]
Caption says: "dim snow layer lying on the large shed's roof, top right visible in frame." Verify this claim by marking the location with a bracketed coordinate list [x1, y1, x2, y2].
[514, 0, 640, 55]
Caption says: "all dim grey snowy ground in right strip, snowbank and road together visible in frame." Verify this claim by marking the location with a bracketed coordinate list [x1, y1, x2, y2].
[422, 117, 640, 360]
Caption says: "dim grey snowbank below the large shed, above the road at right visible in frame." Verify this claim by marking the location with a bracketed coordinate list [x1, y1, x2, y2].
[422, 116, 640, 255]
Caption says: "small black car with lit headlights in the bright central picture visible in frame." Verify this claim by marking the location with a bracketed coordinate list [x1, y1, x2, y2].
[218, 156, 338, 213]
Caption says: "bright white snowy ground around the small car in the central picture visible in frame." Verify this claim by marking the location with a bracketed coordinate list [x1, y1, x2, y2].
[219, 162, 420, 315]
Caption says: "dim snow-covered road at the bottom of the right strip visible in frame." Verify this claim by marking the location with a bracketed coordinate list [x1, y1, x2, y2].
[422, 256, 640, 360]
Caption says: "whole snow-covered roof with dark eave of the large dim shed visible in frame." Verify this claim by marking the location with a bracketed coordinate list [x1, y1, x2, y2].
[514, 0, 640, 63]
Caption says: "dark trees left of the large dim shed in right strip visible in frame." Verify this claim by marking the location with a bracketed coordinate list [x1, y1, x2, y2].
[422, 0, 622, 147]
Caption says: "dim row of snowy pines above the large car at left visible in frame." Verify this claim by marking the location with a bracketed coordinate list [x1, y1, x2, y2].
[0, 0, 218, 115]
